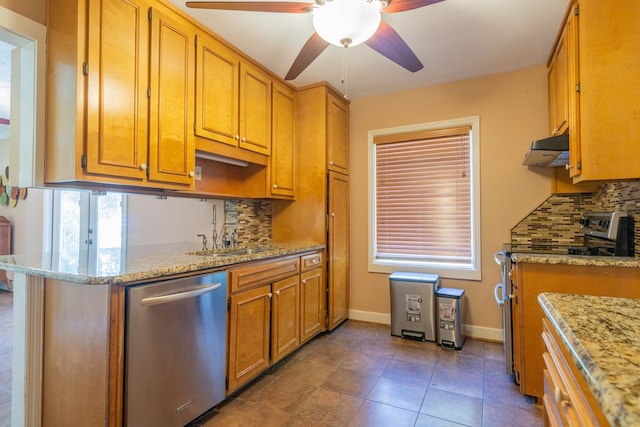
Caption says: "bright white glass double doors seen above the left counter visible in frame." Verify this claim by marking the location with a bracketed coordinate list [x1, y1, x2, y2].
[51, 190, 126, 276]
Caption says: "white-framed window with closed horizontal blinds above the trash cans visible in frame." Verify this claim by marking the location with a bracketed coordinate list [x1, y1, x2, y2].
[369, 117, 480, 280]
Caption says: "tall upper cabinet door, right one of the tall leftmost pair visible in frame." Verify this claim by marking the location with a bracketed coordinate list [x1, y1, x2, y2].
[148, 9, 196, 186]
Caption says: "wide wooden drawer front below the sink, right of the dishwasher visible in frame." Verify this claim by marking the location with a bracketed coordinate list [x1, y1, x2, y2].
[229, 256, 300, 293]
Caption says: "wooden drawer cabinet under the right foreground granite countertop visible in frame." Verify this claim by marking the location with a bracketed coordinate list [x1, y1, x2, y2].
[542, 319, 609, 427]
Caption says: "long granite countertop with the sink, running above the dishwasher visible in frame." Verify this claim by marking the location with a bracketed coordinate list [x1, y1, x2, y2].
[0, 242, 325, 285]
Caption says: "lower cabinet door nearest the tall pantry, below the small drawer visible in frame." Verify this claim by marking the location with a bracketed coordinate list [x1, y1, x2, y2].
[300, 268, 326, 342]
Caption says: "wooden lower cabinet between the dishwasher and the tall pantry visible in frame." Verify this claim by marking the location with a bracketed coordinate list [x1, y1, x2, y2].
[227, 252, 326, 394]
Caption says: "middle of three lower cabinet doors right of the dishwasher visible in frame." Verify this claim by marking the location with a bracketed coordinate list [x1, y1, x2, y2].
[271, 274, 300, 362]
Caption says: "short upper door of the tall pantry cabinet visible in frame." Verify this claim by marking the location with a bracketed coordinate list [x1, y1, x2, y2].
[327, 94, 349, 174]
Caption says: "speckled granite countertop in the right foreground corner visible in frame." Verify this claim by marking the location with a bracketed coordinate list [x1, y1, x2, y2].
[538, 293, 640, 426]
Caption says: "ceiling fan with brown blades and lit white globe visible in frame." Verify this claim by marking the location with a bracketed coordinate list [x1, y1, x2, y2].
[186, 0, 443, 80]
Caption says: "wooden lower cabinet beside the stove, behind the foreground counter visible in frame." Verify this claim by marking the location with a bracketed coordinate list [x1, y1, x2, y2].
[512, 262, 640, 398]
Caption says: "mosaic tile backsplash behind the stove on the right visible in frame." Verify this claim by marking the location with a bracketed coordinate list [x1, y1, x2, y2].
[511, 180, 640, 256]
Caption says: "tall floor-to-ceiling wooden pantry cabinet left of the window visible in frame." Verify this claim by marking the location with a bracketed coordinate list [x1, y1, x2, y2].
[273, 84, 349, 330]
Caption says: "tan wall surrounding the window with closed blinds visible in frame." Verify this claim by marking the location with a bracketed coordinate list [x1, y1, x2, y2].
[350, 66, 550, 332]
